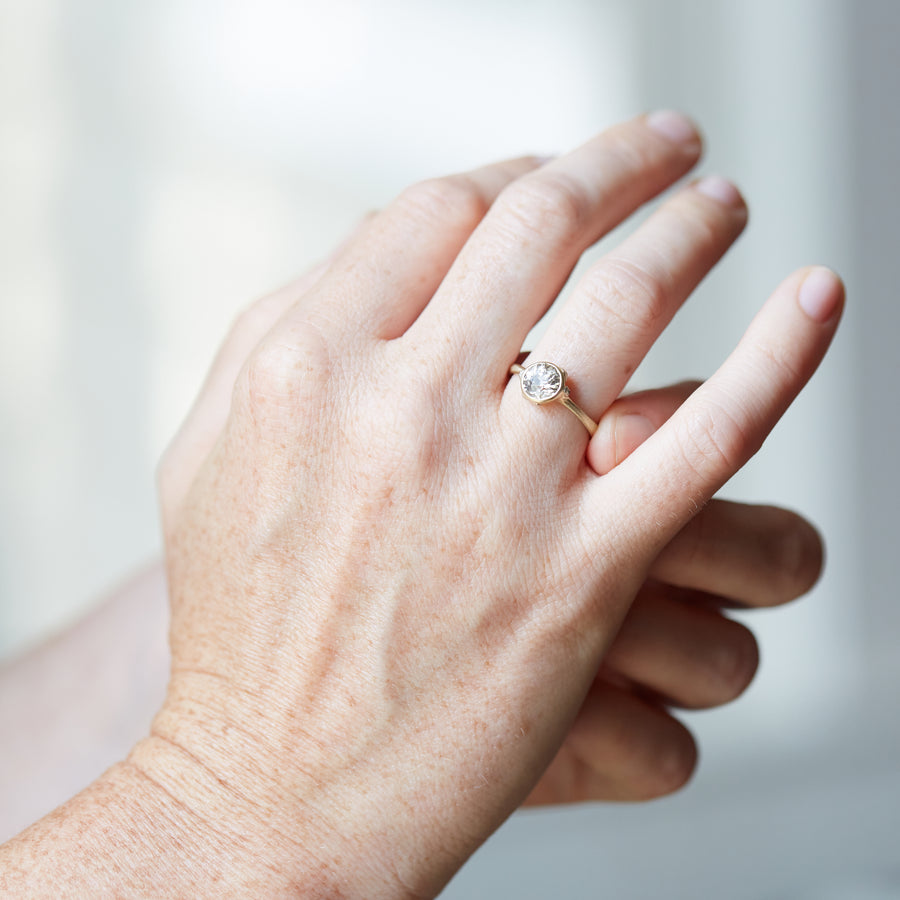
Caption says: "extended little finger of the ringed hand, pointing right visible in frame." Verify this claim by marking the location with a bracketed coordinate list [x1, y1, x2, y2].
[582, 268, 844, 561]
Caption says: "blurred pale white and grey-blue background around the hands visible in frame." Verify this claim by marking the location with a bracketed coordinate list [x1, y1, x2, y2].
[0, 0, 900, 900]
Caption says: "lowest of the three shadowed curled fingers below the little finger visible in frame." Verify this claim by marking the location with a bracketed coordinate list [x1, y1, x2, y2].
[526, 679, 697, 805]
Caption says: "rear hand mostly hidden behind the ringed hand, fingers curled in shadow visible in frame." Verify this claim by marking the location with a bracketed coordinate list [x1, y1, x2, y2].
[161, 255, 823, 805]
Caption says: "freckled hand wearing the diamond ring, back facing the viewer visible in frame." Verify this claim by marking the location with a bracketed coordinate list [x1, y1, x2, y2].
[139, 120, 841, 896]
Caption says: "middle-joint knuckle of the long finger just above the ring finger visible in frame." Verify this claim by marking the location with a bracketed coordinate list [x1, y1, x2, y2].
[492, 171, 591, 241]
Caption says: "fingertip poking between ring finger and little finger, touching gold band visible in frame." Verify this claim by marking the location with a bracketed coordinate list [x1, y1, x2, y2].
[587, 381, 700, 475]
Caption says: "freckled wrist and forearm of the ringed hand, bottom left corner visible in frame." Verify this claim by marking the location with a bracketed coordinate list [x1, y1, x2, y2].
[0, 739, 350, 900]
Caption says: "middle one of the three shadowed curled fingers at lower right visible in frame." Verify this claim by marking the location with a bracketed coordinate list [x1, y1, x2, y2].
[604, 583, 759, 709]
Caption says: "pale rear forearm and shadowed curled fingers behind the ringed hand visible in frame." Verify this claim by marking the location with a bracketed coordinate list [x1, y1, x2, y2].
[0, 398, 821, 840]
